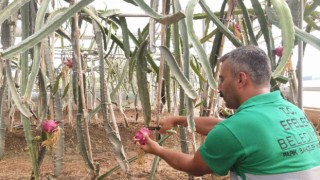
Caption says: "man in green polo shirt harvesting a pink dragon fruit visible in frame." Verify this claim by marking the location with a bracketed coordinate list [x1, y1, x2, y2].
[140, 46, 320, 180]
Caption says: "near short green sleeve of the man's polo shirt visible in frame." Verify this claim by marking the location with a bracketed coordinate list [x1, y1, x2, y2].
[199, 123, 244, 176]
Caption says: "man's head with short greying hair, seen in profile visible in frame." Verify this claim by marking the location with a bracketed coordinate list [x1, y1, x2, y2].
[219, 46, 271, 109]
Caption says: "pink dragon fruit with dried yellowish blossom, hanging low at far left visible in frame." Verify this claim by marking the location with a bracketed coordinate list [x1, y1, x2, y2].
[41, 119, 61, 149]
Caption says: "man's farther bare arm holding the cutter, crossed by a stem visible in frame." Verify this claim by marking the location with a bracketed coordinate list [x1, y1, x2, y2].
[159, 116, 222, 136]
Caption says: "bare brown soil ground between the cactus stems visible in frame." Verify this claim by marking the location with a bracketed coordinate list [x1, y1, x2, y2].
[0, 110, 229, 180]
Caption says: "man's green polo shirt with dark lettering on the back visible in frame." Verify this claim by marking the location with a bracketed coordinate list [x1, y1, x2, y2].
[199, 91, 320, 179]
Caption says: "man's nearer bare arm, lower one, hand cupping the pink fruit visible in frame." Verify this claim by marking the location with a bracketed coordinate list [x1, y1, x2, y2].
[140, 136, 213, 176]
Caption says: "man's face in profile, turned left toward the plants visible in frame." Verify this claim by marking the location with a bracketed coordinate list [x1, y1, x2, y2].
[218, 59, 240, 109]
